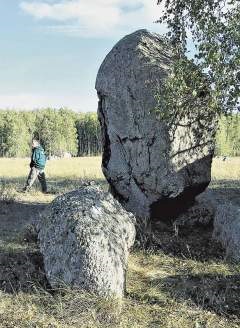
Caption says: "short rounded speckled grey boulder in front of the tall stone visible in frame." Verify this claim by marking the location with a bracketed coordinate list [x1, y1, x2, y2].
[38, 185, 135, 297]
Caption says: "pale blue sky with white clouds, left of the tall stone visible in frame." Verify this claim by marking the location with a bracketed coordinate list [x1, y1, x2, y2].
[0, 0, 167, 111]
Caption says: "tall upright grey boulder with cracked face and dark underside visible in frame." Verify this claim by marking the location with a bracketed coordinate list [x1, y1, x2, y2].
[96, 30, 218, 219]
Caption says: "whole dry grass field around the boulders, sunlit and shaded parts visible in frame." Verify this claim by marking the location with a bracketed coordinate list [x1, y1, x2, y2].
[0, 157, 240, 328]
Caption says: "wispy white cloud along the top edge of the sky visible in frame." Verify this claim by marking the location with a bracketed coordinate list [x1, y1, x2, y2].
[20, 0, 166, 37]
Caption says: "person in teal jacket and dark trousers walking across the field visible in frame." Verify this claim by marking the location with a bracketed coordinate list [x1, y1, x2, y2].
[23, 139, 47, 193]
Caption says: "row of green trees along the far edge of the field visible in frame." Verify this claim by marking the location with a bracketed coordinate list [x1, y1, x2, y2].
[0, 108, 240, 157]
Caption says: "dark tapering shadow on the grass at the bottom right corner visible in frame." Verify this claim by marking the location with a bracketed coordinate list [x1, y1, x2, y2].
[156, 274, 240, 318]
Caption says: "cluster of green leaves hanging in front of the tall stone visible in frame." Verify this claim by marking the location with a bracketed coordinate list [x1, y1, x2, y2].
[155, 57, 214, 129]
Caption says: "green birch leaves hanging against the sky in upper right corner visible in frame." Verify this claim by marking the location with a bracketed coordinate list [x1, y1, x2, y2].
[158, 0, 240, 114]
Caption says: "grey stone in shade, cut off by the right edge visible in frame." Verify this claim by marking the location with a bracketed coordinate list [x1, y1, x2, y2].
[213, 202, 240, 261]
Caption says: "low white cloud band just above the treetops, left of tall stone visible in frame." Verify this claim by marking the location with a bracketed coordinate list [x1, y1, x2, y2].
[0, 90, 98, 112]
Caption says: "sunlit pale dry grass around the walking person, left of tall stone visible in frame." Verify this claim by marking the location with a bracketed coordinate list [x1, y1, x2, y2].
[0, 157, 104, 203]
